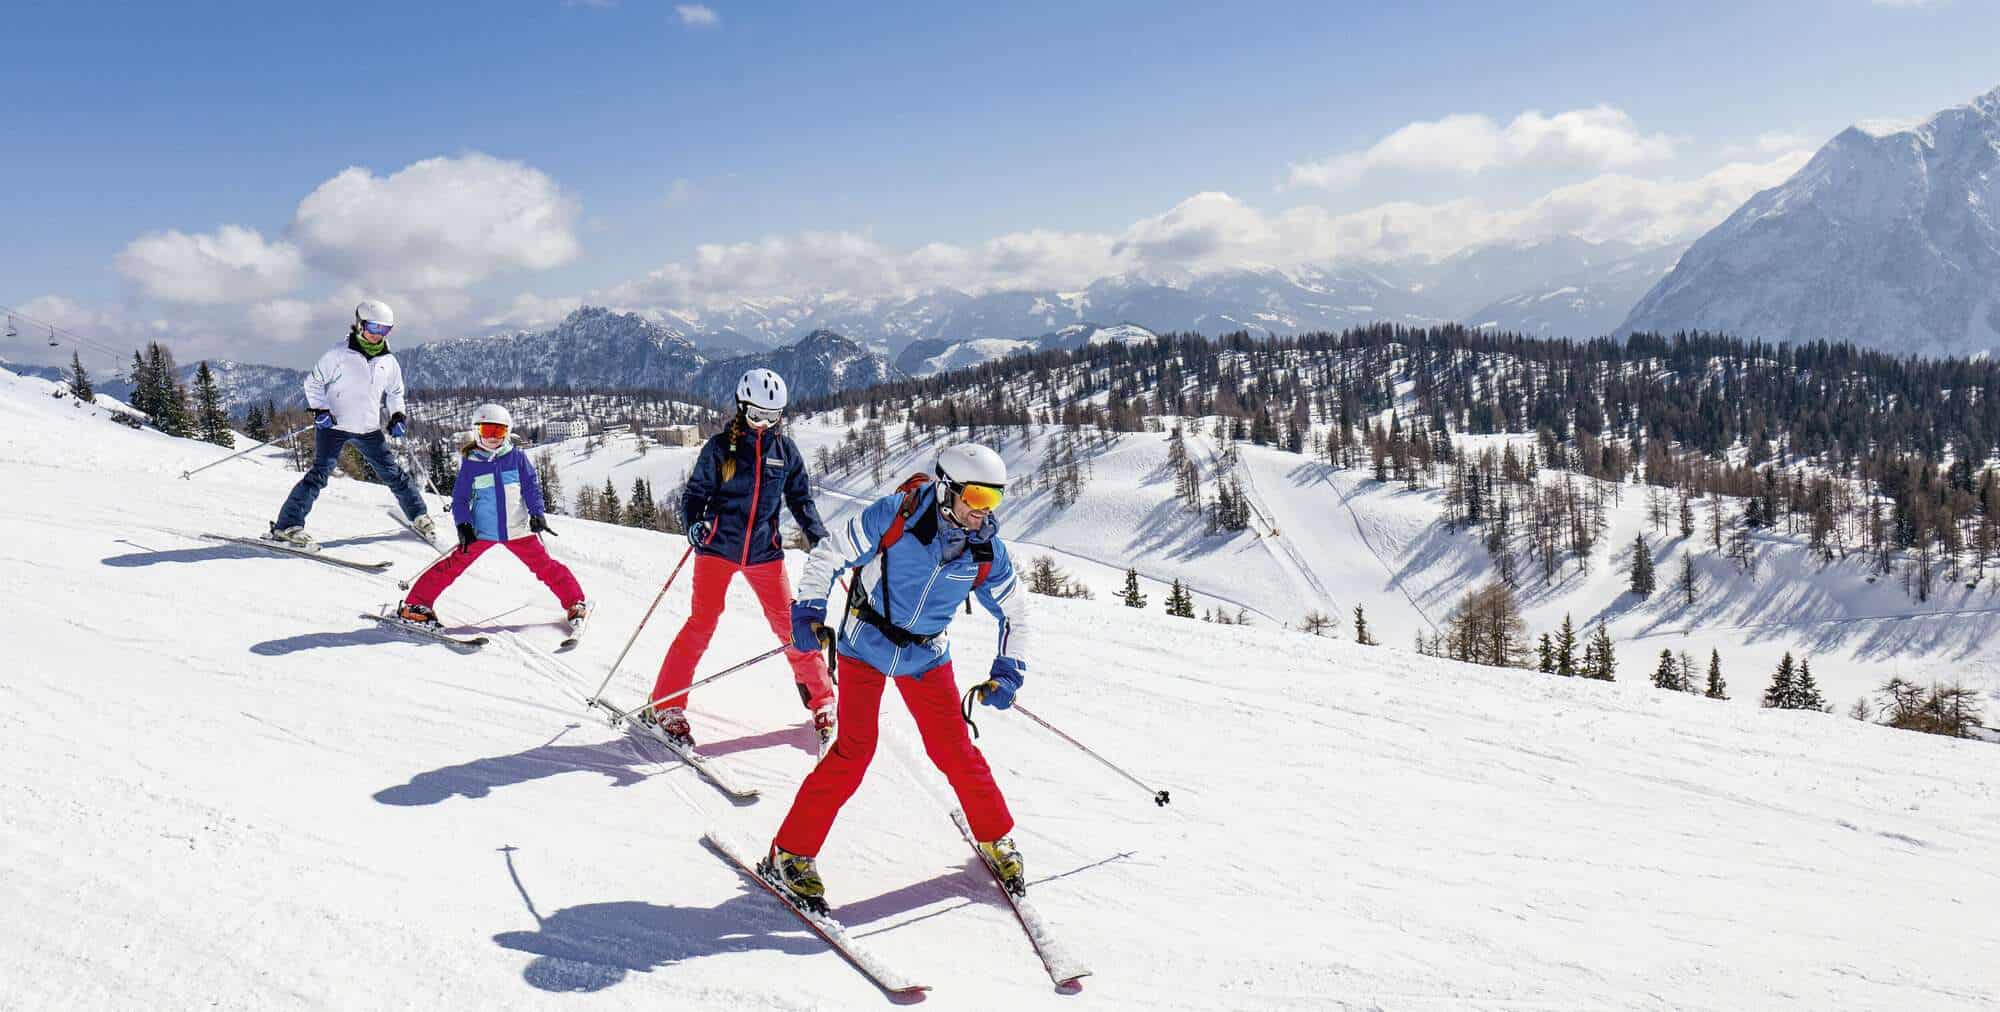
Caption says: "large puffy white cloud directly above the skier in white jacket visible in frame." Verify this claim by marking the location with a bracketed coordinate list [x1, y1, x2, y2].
[292, 154, 580, 290]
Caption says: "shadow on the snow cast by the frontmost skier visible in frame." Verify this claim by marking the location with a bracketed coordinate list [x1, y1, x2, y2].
[494, 846, 826, 994]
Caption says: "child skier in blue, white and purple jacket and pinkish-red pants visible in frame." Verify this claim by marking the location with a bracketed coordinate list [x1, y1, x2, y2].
[396, 404, 590, 632]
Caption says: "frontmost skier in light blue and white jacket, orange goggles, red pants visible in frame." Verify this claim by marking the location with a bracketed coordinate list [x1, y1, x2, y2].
[758, 442, 1028, 906]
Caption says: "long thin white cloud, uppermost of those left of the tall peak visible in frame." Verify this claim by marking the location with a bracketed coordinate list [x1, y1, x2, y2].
[1286, 104, 1674, 190]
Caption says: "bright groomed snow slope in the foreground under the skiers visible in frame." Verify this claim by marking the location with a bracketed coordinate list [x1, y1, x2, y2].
[0, 374, 2000, 1010]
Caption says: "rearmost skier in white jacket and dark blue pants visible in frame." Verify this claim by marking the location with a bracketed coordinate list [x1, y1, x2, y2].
[270, 298, 436, 548]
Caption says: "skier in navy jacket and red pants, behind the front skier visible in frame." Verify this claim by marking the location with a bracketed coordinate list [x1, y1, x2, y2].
[638, 368, 834, 748]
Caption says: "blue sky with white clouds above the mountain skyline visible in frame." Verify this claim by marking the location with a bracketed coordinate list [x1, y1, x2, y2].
[0, 0, 2000, 362]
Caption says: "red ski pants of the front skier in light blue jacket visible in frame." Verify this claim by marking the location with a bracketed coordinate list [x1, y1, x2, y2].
[774, 654, 1014, 858]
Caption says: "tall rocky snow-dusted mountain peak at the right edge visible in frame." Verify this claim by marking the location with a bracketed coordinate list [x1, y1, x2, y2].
[1620, 88, 2000, 356]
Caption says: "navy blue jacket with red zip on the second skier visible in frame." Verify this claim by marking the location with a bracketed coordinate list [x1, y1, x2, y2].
[680, 422, 826, 566]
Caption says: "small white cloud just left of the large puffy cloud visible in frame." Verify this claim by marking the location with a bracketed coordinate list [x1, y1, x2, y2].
[116, 224, 306, 306]
